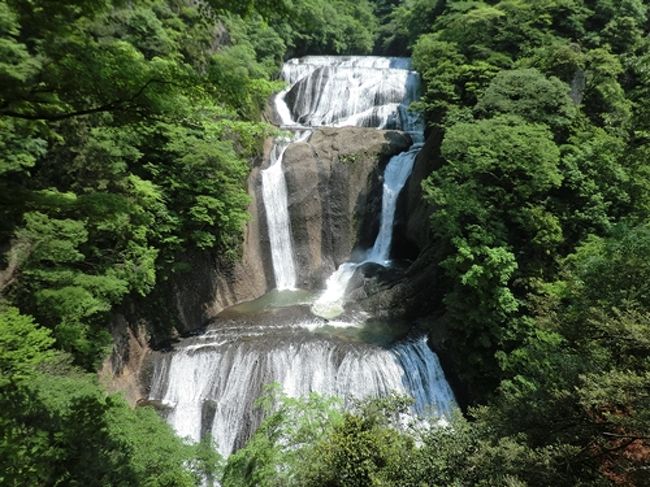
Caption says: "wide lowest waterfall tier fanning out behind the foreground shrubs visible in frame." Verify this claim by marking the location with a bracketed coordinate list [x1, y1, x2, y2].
[150, 327, 455, 456]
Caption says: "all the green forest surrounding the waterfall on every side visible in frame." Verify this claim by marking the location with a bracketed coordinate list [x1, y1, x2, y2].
[0, 0, 650, 486]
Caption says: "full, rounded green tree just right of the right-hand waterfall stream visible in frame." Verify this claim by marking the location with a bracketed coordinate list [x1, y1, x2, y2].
[423, 117, 562, 306]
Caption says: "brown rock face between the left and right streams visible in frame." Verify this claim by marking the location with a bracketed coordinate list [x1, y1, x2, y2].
[283, 127, 411, 288]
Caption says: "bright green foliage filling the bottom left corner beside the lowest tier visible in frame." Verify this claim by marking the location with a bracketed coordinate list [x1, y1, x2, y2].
[0, 308, 219, 486]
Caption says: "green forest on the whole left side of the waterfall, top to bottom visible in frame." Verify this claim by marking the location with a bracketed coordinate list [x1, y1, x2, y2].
[0, 0, 375, 486]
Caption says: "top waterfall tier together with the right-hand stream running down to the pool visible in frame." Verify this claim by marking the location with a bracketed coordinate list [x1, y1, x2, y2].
[302, 57, 424, 319]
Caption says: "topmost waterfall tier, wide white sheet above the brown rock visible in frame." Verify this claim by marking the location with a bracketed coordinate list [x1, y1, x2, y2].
[276, 56, 419, 132]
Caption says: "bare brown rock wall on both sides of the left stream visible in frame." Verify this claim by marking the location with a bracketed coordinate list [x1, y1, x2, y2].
[102, 127, 411, 403]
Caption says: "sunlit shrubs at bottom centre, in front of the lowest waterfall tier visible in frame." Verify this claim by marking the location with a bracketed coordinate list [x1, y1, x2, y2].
[224, 392, 606, 487]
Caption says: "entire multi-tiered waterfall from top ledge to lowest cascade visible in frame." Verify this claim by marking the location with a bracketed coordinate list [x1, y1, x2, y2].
[150, 56, 455, 455]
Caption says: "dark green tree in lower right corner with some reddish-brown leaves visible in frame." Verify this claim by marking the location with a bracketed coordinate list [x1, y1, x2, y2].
[481, 226, 650, 485]
